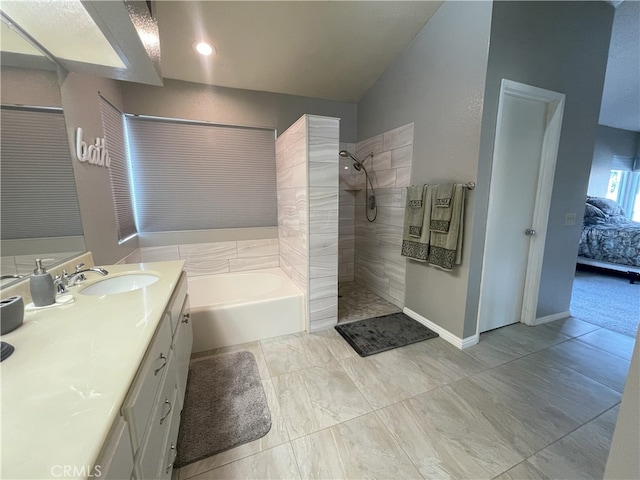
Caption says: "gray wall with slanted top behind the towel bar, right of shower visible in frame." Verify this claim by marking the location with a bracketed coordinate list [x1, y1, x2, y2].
[358, 2, 491, 337]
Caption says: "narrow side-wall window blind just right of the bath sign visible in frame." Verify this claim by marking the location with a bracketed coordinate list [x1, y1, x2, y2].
[100, 97, 137, 242]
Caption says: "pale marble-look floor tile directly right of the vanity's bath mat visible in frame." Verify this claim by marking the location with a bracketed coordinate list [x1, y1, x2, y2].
[272, 362, 371, 439]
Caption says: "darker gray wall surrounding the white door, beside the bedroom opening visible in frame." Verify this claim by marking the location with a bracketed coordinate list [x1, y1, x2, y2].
[465, 2, 614, 328]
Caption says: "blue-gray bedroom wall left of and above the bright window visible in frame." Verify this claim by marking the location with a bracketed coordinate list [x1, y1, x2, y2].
[587, 125, 640, 197]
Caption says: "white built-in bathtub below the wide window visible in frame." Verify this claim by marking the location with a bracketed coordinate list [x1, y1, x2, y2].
[187, 268, 305, 353]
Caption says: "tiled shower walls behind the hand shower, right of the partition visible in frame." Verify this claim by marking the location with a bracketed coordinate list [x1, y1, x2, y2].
[338, 123, 414, 308]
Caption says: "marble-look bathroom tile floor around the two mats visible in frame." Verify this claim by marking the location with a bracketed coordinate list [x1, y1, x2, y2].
[174, 318, 633, 480]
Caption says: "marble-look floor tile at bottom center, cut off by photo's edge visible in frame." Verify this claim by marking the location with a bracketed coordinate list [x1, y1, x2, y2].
[291, 413, 422, 480]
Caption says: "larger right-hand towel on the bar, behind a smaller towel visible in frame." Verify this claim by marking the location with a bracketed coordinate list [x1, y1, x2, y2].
[429, 183, 464, 271]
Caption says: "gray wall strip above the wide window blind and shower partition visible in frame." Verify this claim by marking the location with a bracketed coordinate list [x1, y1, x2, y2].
[122, 79, 357, 142]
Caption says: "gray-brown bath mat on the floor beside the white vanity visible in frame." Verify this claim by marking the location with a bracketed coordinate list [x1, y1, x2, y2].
[175, 352, 271, 467]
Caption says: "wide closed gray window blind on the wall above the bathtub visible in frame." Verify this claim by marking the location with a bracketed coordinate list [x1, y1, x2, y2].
[127, 116, 277, 232]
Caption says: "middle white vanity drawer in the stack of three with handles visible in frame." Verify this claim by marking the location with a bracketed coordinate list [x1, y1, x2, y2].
[137, 355, 180, 479]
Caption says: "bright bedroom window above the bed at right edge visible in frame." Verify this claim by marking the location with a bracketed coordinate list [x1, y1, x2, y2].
[606, 156, 640, 222]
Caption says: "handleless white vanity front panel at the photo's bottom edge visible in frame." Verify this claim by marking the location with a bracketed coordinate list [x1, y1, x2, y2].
[92, 416, 133, 480]
